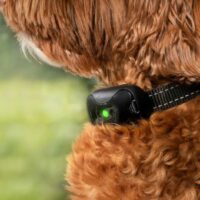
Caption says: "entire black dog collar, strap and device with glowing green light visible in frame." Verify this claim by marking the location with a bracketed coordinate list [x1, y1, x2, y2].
[87, 84, 200, 124]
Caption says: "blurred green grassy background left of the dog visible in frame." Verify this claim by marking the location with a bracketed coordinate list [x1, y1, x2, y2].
[0, 14, 92, 200]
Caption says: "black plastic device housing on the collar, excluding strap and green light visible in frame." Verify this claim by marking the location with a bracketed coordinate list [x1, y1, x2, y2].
[87, 85, 153, 124]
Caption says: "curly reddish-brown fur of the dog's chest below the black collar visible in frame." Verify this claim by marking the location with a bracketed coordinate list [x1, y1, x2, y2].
[68, 99, 200, 200]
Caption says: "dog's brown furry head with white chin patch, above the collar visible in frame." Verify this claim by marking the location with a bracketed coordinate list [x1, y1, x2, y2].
[0, 0, 200, 88]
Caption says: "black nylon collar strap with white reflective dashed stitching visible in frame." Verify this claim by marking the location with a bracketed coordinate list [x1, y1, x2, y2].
[148, 84, 200, 111]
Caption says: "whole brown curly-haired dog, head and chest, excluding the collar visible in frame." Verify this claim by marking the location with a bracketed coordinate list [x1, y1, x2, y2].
[0, 0, 200, 200]
